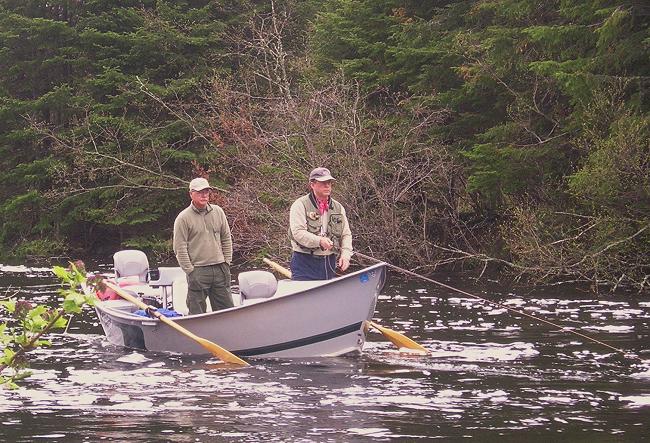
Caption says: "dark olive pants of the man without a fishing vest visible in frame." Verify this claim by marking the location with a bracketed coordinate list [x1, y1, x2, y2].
[187, 263, 233, 314]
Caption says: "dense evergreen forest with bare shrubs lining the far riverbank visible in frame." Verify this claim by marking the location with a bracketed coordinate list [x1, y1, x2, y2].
[0, 0, 650, 290]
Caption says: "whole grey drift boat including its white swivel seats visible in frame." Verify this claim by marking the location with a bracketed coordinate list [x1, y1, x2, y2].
[90, 250, 386, 357]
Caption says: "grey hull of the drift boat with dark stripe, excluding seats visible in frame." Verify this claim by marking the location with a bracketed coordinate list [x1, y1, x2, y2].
[96, 263, 386, 358]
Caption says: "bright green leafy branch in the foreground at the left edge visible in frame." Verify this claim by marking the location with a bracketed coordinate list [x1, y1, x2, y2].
[0, 262, 95, 388]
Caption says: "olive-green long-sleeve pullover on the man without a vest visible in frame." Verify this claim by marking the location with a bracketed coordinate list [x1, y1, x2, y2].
[173, 204, 232, 274]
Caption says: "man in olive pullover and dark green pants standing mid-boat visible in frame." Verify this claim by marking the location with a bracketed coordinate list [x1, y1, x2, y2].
[174, 177, 233, 314]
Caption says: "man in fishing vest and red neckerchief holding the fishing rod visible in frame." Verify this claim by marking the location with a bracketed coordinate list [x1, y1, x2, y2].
[289, 168, 352, 280]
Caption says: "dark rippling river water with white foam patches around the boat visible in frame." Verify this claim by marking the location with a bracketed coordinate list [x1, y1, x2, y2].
[0, 266, 650, 442]
